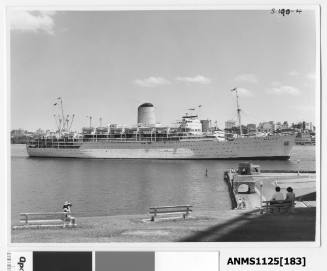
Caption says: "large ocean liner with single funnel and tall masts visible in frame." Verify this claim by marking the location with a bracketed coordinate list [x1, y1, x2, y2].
[26, 88, 294, 159]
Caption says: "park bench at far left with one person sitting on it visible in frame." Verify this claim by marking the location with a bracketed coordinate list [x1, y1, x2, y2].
[13, 212, 76, 229]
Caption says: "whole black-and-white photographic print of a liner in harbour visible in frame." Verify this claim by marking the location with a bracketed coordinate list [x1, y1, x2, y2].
[7, 5, 321, 244]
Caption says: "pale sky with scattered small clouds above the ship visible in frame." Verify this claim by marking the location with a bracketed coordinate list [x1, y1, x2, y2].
[8, 10, 316, 131]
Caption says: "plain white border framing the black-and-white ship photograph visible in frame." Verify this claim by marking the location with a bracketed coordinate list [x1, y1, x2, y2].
[2, 1, 326, 260]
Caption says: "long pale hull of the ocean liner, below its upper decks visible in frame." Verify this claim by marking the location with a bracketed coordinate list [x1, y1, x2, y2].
[27, 136, 294, 159]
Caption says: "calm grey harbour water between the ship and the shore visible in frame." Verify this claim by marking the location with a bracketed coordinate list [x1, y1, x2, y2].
[11, 145, 316, 223]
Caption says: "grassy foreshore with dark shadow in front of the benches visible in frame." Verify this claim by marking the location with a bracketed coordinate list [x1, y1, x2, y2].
[12, 208, 316, 243]
